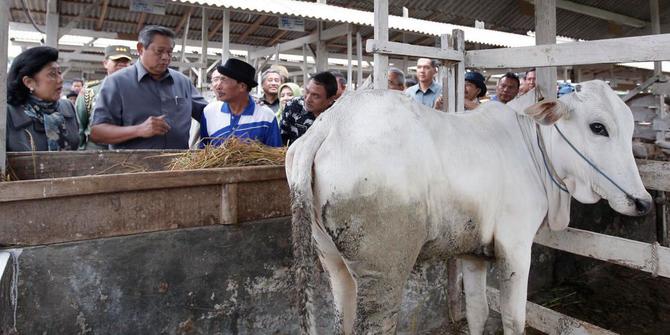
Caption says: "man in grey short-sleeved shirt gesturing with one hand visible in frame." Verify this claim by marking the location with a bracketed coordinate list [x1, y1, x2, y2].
[91, 26, 207, 149]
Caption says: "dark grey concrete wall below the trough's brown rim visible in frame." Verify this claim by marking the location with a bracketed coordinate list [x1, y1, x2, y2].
[0, 218, 447, 334]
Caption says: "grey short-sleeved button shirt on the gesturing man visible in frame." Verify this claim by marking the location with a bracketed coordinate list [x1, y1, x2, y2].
[92, 61, 207, 149]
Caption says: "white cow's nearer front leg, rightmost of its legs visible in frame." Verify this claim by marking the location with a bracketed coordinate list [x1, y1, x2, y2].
[496, 238, 532, 335]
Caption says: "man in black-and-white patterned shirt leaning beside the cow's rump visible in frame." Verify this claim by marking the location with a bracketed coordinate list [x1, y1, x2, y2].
[280, 72, 337, 145]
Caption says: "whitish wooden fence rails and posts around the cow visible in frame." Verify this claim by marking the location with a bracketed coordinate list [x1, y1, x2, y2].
[366, 0, 670, 334]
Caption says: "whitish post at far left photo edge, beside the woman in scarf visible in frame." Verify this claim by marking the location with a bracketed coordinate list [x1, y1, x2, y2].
[0, 1, 9, 180]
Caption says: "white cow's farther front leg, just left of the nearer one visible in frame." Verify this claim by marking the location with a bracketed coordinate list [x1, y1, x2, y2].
[462, 257, 489, 335]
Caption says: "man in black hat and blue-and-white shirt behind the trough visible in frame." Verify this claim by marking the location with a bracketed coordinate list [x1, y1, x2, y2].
[200, 58, 282, 147]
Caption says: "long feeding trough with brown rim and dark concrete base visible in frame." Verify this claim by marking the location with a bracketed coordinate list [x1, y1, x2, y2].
[0, 151, 447, 334]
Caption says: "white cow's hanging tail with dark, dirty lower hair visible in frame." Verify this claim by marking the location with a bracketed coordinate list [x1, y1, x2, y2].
[286, 119, 327, 334]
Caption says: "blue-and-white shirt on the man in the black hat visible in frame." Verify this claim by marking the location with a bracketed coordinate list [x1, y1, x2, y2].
[200, 96, 282, 147]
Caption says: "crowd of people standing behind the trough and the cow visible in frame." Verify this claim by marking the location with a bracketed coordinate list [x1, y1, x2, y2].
[7, 26, 570, 151]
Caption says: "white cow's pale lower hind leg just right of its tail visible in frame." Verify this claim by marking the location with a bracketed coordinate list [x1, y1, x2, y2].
[320, 254, 356, 335]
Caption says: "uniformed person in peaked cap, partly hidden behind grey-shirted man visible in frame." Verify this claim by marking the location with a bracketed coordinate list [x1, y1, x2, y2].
[75, 45, 133, 150]
